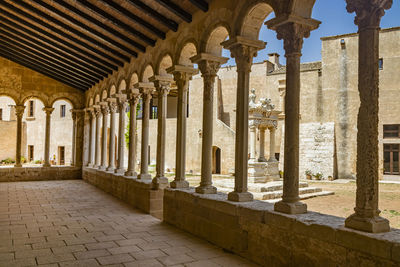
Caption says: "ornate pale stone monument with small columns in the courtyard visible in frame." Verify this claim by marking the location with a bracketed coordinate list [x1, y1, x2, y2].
[248, 89, 281, 183]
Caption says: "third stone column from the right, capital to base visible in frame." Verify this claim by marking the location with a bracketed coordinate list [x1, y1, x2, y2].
[222, 36, 265, 201]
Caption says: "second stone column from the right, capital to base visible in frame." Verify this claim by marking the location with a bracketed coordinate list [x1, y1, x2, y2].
[266, 17, 319, 214]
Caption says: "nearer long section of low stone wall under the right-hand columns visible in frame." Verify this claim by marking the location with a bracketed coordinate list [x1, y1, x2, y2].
[164, 189, 400, 266]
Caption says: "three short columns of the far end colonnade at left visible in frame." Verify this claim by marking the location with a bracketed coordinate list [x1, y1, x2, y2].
[14, 105, 84, 167]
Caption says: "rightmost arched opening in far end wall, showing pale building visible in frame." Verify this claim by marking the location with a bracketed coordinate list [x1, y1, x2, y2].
[50, 99, 74, 165]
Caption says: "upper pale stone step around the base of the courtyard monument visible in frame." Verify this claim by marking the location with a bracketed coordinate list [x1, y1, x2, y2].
[213, 180, 308, 193]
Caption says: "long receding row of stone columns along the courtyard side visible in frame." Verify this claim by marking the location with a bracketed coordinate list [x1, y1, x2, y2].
[83, 0, 391, 232]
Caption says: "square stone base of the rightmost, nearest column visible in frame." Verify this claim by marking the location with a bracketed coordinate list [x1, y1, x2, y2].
[344, 213, 390, 233]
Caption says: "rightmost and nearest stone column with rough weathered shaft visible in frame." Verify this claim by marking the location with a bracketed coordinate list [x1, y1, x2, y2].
[344, 0, 392, 233]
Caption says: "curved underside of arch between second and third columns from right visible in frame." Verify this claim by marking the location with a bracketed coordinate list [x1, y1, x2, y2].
[236, 0, 278, 40]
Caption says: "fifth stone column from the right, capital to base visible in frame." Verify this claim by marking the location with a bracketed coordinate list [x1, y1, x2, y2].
[167, 65, 198, 188]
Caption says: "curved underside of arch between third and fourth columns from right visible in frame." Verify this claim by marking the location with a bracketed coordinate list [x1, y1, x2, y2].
[202, 23, 230, 56]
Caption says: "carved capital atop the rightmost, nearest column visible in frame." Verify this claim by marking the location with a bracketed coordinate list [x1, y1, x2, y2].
[346, 0, 393, 29]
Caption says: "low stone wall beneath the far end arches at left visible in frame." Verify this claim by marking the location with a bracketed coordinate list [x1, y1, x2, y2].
[0, 166, 82, 182]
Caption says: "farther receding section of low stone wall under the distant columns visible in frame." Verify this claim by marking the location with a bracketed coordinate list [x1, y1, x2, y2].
[82, 167, 164, 219]
